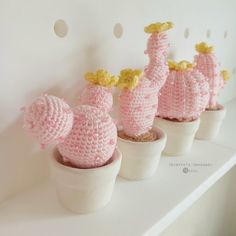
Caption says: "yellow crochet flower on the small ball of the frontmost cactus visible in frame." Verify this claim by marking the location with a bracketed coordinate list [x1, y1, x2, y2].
[85, 70, 119, 88]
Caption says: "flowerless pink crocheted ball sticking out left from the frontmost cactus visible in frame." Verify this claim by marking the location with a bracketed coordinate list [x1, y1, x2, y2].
[24, 95, 73, 147]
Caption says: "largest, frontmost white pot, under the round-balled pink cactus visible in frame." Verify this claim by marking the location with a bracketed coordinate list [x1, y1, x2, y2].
[49, 149, 121, 214]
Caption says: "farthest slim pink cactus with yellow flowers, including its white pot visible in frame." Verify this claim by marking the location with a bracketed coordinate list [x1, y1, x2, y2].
[194, 42, 229, 140]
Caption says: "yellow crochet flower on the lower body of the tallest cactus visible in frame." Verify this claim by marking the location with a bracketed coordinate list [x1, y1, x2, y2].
[116, 69, 142, 90]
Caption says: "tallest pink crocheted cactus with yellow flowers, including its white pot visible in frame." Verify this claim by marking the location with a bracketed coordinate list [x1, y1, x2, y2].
[117, 22, 172, 180]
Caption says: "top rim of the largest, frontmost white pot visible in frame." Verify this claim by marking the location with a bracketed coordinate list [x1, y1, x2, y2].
[49, 147, 122, 173]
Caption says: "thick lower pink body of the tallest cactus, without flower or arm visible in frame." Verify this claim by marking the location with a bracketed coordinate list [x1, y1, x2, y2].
[119, 78, 158, 137]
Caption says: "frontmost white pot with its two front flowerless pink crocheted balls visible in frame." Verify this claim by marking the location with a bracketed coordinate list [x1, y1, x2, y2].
[24, 95, 121, 213]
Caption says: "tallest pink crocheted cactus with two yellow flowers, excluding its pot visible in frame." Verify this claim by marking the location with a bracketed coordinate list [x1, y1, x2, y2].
[117, 22, 172, 137]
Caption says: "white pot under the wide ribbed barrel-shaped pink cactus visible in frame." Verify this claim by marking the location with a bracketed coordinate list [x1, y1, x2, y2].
[154, 117, 200, 156]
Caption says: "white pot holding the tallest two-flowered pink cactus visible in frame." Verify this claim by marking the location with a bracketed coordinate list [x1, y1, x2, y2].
[118, 128, 166, 180]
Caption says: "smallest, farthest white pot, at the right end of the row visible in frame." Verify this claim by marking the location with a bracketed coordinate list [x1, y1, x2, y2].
[195, 106, 226, 140]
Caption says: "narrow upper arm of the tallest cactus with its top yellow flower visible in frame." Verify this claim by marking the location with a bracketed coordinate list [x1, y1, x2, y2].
[144, 22, 173, 89]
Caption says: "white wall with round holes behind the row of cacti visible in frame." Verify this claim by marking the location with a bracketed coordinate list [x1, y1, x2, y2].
[0, 0, 236, 225]
